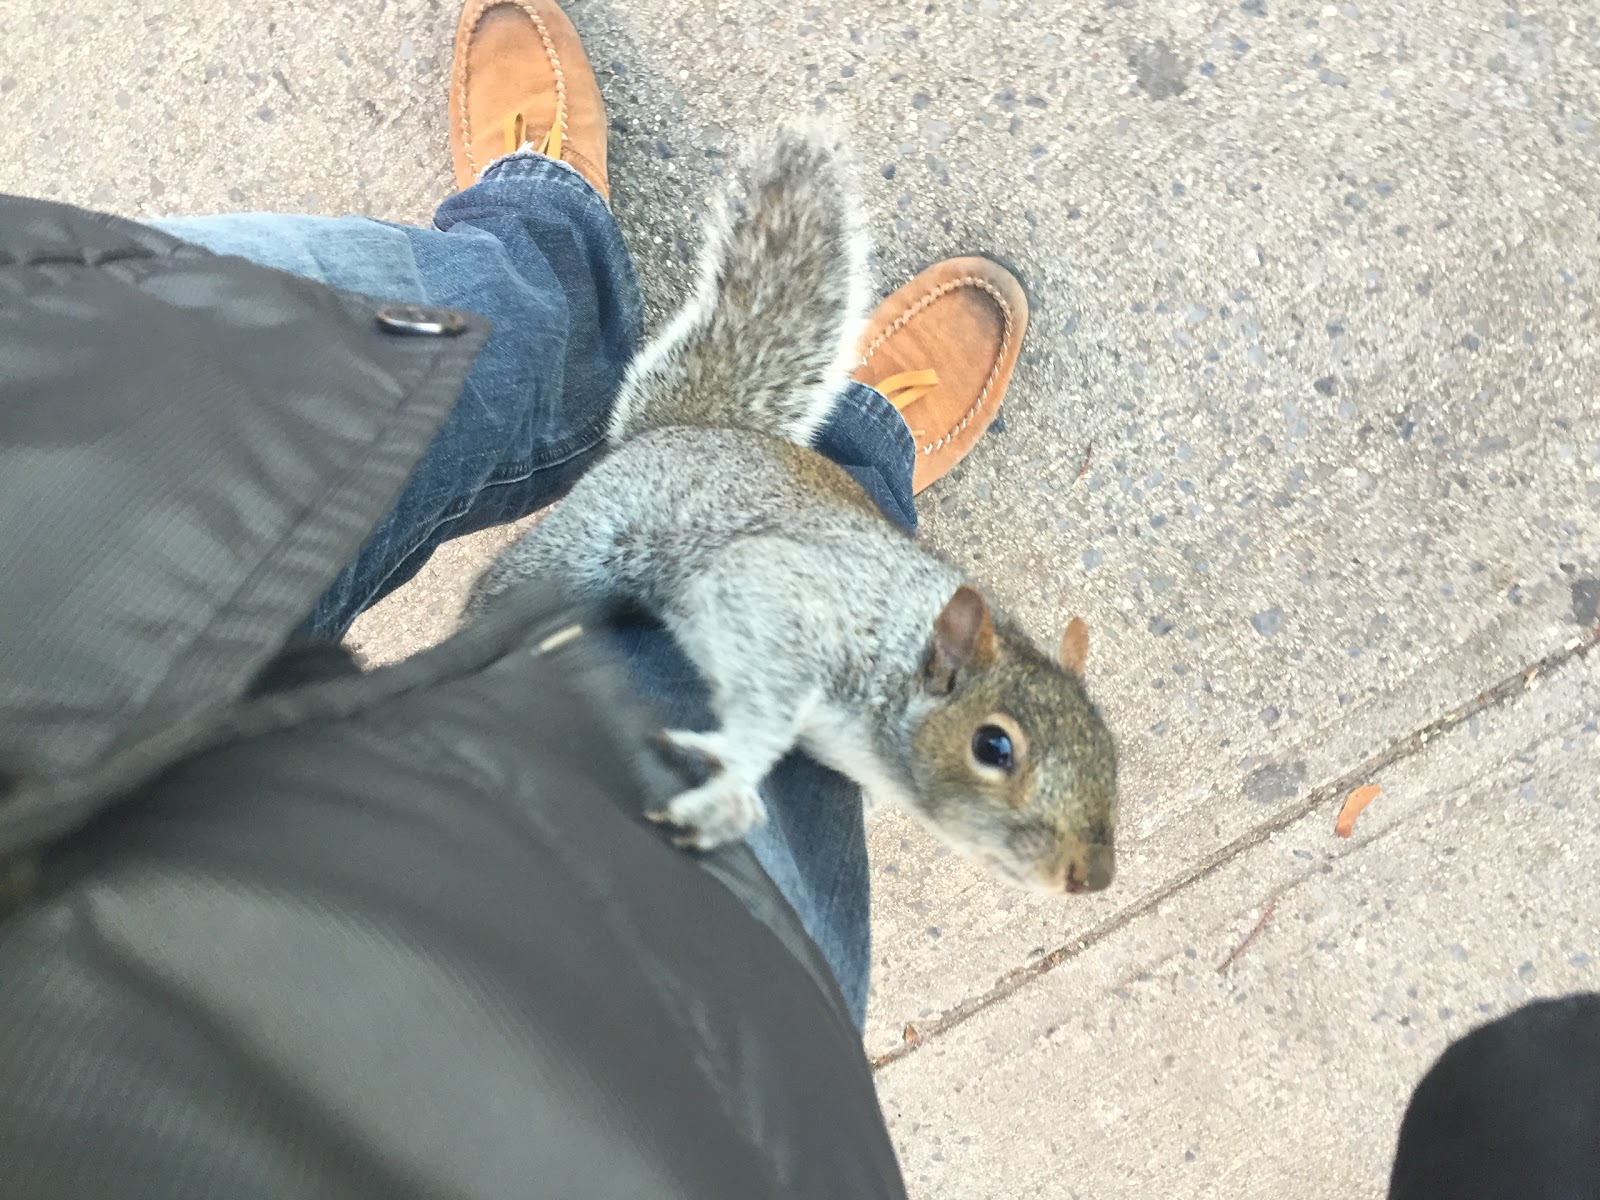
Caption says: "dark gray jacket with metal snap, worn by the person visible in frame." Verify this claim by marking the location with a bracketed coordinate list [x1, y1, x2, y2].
[0, 200, 902, 1200]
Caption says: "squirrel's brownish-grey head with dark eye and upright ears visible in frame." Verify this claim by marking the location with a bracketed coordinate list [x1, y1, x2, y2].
[910, 587, 1117, 893]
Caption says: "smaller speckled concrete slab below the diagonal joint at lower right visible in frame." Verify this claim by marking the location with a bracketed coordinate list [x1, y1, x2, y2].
[880, 654, 1600, 1200]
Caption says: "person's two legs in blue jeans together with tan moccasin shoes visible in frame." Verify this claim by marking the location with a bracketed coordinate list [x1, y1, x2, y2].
[144, 0, 1026, 1026]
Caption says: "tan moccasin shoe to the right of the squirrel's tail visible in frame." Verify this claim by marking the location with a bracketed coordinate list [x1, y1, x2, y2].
[854, 258, 1027, 491]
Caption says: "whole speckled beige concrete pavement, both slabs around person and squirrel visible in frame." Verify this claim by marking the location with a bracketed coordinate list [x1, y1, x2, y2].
[0, 0, 1600, 1198]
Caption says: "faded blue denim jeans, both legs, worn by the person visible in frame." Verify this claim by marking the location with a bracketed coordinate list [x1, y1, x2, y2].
[154, 152, 917, 1027]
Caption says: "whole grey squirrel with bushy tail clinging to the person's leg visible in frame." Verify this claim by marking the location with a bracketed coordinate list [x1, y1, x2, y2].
[466, 126, 1117, 893]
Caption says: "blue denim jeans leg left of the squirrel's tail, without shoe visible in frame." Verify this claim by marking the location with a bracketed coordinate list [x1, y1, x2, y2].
[154, 154, 642, 638]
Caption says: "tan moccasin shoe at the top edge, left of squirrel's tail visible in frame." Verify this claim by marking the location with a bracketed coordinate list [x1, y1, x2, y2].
[450, 0, 611, 203]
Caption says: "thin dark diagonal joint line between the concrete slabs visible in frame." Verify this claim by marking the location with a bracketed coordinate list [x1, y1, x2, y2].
[870, 626, 1600, 1070]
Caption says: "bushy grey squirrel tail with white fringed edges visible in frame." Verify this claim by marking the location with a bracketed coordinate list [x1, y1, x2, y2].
[611, 128, 867, 445]
